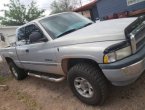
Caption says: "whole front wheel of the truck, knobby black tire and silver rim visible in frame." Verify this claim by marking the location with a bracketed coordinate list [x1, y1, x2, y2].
[68, 63, 108, 105]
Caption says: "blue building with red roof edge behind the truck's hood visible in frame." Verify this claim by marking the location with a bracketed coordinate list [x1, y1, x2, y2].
[74, 0, 145, 21]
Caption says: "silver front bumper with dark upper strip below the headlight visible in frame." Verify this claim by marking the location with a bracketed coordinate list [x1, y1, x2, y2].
[100, 48, 145, 86]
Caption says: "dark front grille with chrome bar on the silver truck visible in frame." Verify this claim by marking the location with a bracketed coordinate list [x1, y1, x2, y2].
[125, 15, 145, 53]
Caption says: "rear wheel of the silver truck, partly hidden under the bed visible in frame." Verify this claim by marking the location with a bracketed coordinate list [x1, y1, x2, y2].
[9, 61, 28, 80]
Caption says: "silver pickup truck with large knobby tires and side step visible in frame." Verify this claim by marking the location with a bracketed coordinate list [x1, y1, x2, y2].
[0, 12, 145, 105]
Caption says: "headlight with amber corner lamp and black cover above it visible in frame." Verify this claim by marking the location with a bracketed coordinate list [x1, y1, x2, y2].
[103, 42, 132, 63]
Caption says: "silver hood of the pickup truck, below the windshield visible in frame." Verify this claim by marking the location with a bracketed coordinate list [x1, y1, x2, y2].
[54, 18, 137, 45]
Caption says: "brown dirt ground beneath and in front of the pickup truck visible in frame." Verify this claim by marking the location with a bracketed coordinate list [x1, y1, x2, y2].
[0, 64, 145, 110]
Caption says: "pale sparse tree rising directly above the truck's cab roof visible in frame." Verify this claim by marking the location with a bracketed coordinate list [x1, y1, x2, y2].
[51, 0, 78, 14]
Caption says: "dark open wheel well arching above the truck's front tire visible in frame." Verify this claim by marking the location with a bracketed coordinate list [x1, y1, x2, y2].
[62, 58, 101, 74]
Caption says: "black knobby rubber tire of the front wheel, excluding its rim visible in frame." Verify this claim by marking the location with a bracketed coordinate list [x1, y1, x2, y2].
[68, 63, 108, 105]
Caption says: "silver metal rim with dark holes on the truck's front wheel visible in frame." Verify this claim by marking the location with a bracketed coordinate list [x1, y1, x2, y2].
[74, 77, 94, 98]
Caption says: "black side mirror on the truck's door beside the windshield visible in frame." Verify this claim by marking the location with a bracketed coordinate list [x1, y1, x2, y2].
[29, 32, 48, 43]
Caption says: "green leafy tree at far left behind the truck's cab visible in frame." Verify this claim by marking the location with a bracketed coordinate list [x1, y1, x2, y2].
[0, 0, 44, 26]
